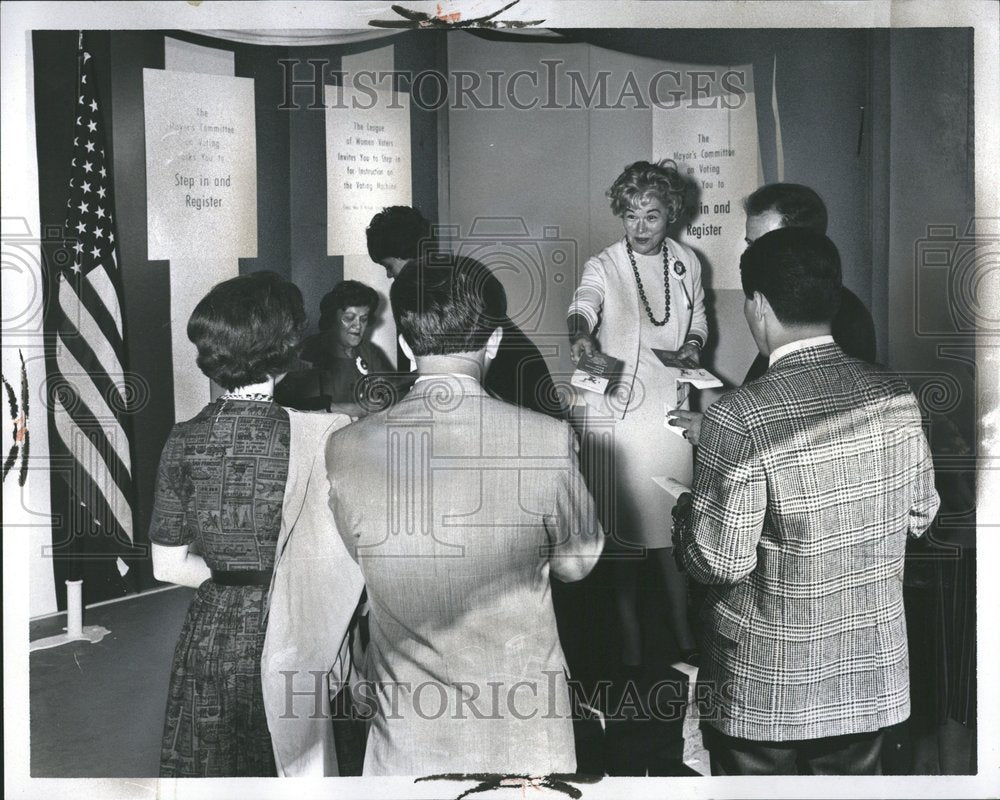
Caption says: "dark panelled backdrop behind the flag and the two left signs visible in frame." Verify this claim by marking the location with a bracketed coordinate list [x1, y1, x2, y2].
[32, 31, 444, 608]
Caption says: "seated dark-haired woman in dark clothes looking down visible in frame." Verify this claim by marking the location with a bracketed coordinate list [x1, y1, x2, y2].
[275, 281, 395, 417]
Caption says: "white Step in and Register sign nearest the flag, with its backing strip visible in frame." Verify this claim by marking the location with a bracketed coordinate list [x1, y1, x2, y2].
[143, 63, 257, 421]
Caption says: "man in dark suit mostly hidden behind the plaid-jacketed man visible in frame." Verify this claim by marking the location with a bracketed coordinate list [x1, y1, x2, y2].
[671, 183, 875, 445]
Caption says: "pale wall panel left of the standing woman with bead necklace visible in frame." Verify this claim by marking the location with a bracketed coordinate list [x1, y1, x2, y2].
[447, 35, 592, 388]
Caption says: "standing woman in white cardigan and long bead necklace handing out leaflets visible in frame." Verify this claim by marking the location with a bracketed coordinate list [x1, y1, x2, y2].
[568, 160, 708, 674]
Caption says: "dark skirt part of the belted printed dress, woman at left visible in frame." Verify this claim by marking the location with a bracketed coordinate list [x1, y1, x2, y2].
[160, 581, 276, 778]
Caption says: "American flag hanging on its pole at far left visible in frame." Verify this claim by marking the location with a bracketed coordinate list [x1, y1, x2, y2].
[48, 34, 134, 588]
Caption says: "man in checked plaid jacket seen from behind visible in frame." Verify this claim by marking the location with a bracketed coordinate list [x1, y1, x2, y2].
[678, 228, 938, 775]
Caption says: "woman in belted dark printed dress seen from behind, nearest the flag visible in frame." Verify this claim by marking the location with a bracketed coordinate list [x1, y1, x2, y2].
[149, 272, 305, 777]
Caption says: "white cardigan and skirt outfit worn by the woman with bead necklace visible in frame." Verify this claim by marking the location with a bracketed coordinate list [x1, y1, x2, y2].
[568, 238, 708, 549]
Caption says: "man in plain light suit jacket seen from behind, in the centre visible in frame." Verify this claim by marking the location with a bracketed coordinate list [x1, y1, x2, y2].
[326, 257, 604, 775]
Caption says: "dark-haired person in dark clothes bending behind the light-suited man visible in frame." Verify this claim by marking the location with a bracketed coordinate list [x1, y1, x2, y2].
[366, 206, 564, 418]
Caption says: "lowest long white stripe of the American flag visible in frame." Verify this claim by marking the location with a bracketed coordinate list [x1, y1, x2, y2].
[53, 402, 133, 542]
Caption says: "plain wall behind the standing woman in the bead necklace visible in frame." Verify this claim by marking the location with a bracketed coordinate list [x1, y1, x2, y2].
[447, 30, 881, 396]
